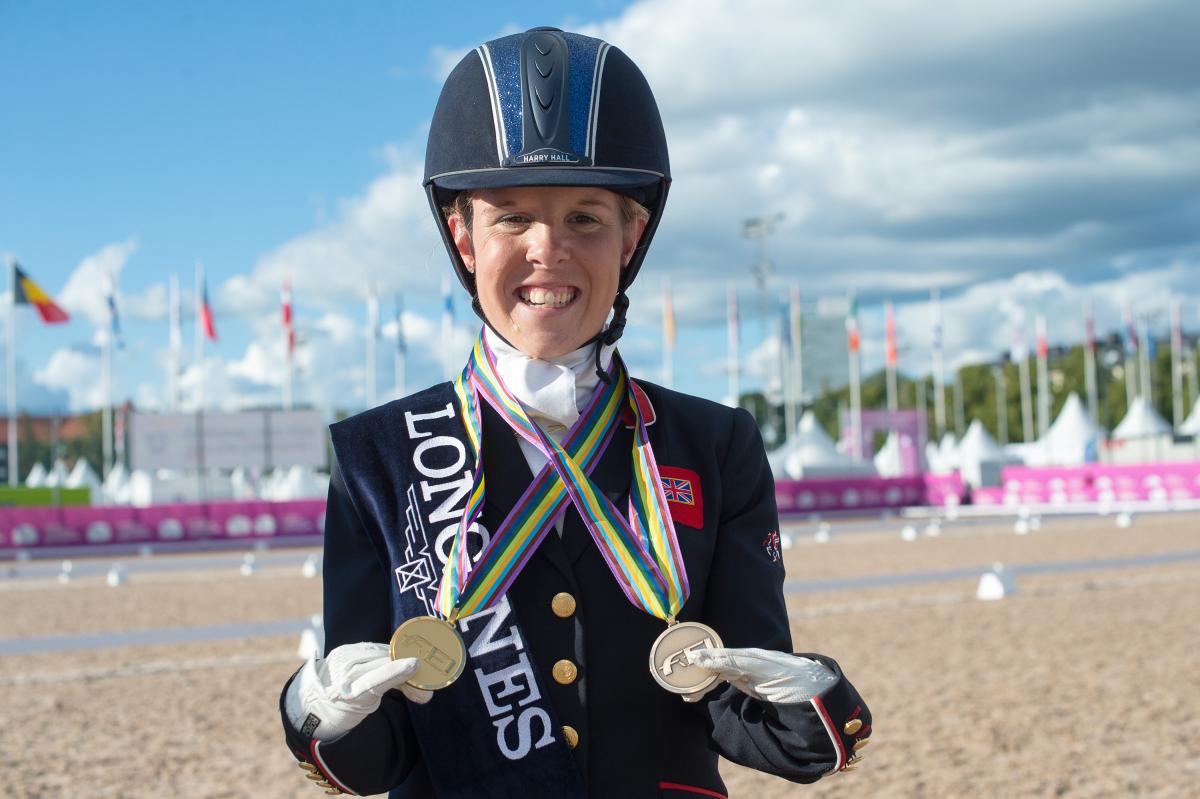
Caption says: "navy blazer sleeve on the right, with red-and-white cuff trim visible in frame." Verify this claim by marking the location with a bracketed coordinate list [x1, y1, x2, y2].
[701, 408, 870, 782]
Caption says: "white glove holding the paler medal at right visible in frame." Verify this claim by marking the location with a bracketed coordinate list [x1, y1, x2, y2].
[684, 649, 838, 704]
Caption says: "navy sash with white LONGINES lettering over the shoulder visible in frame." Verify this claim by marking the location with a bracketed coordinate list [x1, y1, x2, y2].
[330, 383, 587, 799]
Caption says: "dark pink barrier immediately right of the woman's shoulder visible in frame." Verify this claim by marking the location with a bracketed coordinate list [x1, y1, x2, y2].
[775, 474, 964, 513]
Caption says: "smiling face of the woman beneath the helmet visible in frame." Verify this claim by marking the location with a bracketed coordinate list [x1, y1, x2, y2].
[449, 186, 646, 359]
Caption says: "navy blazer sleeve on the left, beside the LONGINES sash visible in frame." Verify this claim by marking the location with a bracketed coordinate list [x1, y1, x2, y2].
[280, 463, 432, 797]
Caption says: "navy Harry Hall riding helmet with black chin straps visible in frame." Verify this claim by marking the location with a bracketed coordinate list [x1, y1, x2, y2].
[425, 28, 671, 345]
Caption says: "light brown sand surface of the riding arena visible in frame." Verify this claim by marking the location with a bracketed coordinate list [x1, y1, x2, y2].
[0, 506, 1200, 799]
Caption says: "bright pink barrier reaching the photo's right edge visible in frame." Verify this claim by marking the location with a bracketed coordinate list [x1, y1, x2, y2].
[971, 462, 1200, 505]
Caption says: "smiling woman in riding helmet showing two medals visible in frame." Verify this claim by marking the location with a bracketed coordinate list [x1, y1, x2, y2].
[281, 29, 871, 798]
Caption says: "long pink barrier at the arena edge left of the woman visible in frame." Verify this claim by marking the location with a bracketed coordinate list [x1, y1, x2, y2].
[0, 499, 325, 551]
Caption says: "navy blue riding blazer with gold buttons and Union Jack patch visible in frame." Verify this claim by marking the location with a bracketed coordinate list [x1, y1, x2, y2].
[281, 382, 871, 799]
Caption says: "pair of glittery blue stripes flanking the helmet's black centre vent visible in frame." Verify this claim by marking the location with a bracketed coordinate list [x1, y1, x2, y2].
[478, 32, 608, 163]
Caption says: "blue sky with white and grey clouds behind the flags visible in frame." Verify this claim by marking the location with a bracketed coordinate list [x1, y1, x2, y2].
[0, 0, 1200, 415]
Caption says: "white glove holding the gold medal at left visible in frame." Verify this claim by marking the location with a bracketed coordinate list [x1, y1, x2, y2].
[284, 643, 433, 740]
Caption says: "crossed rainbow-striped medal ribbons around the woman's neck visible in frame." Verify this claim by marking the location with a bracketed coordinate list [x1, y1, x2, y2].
[437, 334, 689, 621]
